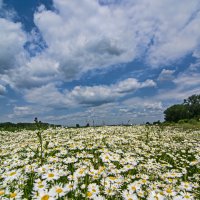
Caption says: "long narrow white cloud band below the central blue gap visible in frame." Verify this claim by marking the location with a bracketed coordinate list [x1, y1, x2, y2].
[25, 78, 156, 107]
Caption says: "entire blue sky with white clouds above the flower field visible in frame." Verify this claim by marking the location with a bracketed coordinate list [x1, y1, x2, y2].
[0, 0, 200, 125]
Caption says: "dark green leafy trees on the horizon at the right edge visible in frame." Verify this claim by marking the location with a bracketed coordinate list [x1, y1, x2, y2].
[164, 95, 200, 124]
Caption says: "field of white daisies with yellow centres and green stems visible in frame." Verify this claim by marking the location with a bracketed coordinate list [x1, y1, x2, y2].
[0, 126, 200, 200]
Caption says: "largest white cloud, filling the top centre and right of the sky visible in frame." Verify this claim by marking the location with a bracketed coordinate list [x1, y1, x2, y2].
[30, 0, 200, 80]
